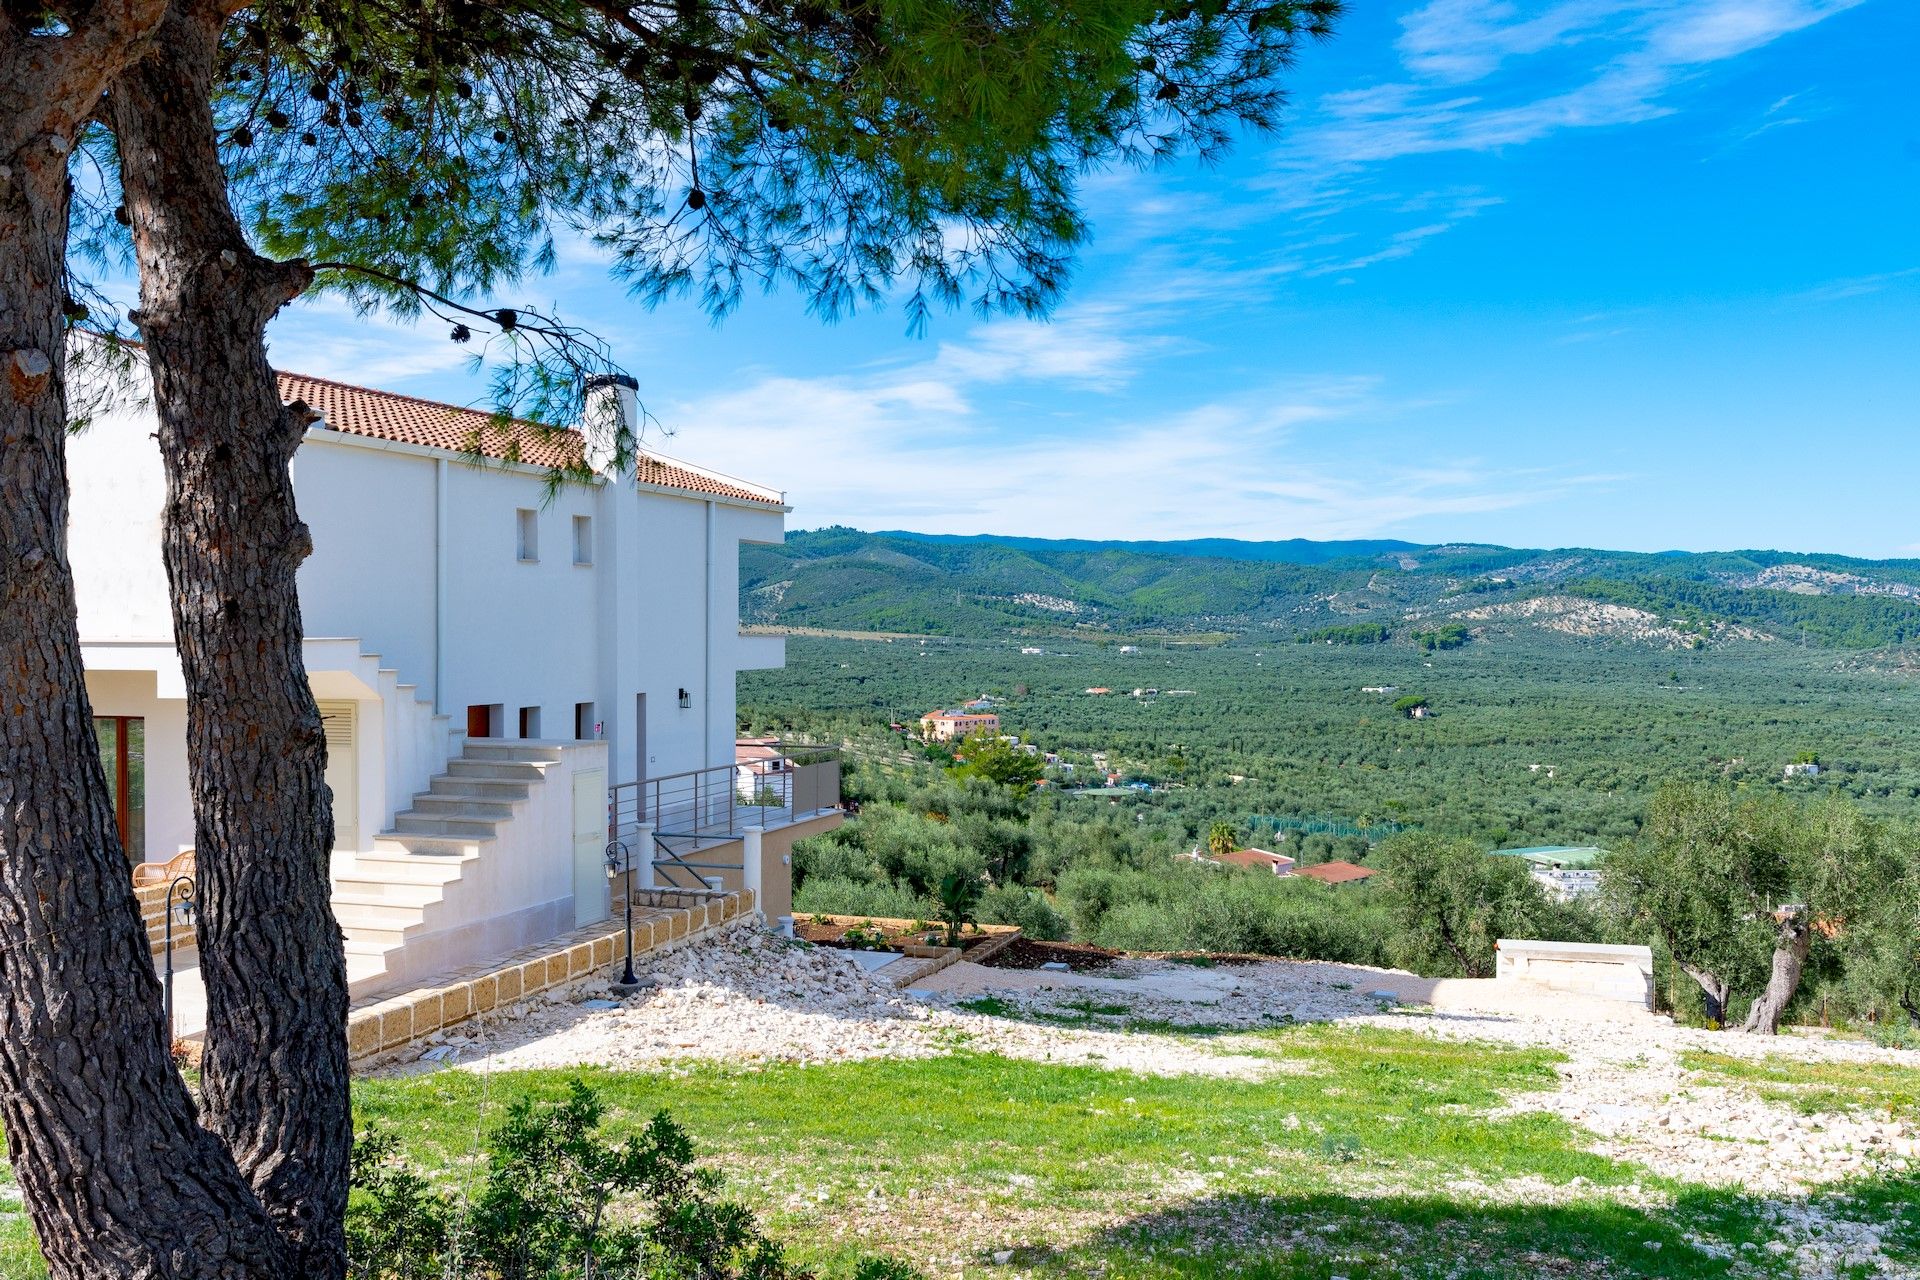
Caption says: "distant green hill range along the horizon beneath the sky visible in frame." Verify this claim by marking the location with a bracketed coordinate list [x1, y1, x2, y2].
[741, 528, 1920, 649]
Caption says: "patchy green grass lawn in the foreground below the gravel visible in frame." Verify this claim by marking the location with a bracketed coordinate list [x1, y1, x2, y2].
[0, 1027, 1920, 1280]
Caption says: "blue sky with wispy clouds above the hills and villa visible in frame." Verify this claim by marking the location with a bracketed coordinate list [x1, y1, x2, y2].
[273, 0, 1920, 557]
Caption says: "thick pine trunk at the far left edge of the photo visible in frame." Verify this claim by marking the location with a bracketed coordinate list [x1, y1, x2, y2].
[0, 55, 291, 1280]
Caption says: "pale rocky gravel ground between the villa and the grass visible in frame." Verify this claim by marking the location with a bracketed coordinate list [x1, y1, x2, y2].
[386, 925, 1920, 1276]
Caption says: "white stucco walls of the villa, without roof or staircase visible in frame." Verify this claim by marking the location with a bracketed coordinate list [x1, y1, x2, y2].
[69, 376, 783, 848]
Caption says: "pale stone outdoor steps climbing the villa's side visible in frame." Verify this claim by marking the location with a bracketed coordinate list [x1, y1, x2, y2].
[334, 741, 561, 994]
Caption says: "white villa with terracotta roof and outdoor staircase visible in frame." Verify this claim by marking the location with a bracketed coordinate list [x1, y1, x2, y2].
[67, 364, 839, 992]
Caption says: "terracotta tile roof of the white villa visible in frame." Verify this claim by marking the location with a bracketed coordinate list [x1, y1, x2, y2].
[278, 372, 780, 507]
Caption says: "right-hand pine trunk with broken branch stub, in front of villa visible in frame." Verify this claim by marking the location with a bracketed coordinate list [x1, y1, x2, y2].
[111, 4, 353, 1280]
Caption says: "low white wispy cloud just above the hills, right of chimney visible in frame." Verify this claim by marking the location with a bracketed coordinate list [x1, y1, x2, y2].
[659, 324, 1605, 537]
